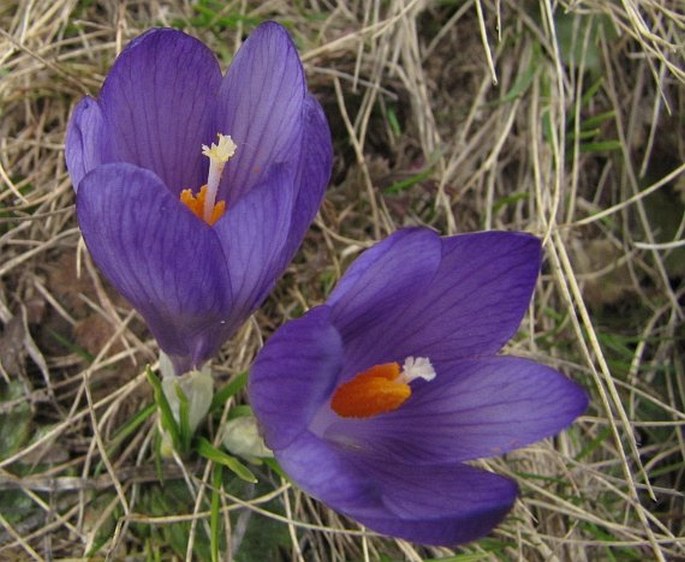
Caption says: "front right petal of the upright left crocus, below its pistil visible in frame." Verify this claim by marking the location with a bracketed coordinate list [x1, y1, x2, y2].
[214, 166, 295, 328]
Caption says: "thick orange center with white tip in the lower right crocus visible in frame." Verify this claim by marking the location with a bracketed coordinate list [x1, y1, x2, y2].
[331, 357, 436, 418]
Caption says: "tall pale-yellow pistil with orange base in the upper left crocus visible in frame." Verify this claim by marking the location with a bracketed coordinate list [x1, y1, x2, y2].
[180, 133, 237, 226]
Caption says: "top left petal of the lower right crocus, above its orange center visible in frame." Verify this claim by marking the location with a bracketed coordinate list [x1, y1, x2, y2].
[327, 228, 441, 375]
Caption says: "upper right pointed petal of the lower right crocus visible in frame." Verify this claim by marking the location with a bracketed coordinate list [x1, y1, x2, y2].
[366, 232, 541, 362]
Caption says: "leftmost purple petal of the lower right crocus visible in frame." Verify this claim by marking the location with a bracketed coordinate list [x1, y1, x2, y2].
[248, 306, 342, 449]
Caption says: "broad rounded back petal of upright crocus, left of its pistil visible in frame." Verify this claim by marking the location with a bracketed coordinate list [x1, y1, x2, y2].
[99, 29, 221, 194]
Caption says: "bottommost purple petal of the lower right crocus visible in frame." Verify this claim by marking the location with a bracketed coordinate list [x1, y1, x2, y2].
[274, 432, 517, 545]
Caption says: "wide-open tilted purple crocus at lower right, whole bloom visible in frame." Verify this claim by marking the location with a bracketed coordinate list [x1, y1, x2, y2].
[249, 229, 587, 545]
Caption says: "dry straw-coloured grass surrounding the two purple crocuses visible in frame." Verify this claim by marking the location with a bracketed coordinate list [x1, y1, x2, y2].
[0, 0, 685, 562]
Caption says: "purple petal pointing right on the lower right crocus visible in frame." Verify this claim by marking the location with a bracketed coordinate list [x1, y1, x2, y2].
[325, 357, 587, 464]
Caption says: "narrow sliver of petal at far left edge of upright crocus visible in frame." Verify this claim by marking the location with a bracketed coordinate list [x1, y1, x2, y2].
[64, 96, 103, 191]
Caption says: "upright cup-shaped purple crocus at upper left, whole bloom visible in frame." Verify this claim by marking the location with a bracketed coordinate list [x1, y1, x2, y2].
[66, 22, 332, 374]
